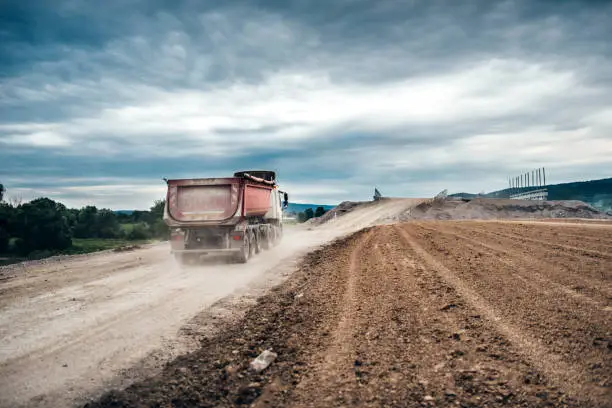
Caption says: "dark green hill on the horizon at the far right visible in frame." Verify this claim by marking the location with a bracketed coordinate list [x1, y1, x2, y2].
[449, 177, 612, 211]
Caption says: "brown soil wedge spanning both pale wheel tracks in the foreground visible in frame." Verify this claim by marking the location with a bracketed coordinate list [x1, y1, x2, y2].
[294, 228, 592, 407]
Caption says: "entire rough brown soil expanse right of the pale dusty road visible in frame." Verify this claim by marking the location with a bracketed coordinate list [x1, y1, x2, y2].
[89, 221, 612, 408]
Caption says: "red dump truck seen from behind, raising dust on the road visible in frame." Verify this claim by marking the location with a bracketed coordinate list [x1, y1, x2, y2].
[164, 171, 289, 263]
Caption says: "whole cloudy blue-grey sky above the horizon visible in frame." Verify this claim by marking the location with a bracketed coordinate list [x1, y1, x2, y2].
[0, 0, 612, 209]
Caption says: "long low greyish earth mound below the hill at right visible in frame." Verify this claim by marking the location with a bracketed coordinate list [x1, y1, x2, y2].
[398, 198, 612, 221]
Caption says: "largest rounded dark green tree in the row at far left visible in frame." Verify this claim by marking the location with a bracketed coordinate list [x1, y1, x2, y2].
[16, 198, 72, 255]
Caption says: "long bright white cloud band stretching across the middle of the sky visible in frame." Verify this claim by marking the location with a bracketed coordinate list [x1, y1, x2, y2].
[0, 60, 578, 156]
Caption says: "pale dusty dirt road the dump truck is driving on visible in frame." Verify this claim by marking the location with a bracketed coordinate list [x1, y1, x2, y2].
[0, 200, 420, 407]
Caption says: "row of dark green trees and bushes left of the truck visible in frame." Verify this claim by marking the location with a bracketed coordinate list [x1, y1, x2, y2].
[0, 184, 168, 256]
